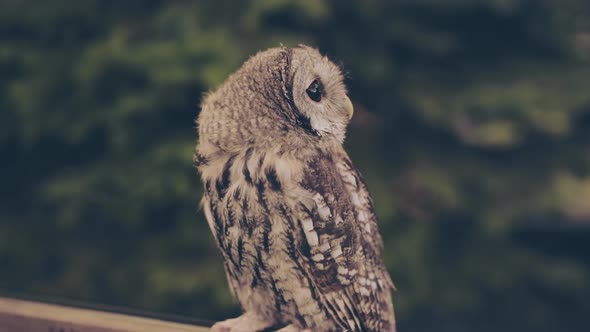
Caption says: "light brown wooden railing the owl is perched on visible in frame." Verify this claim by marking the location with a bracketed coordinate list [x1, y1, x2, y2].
[0, 297, 209, 332]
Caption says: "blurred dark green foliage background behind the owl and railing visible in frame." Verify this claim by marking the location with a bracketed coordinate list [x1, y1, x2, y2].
[0, 0, 590, 332]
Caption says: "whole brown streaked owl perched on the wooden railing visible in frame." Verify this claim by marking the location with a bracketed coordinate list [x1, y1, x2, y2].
[194, 45, 395, 332]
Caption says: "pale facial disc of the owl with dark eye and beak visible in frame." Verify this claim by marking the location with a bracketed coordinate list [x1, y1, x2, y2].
[292, 46, 353, 141]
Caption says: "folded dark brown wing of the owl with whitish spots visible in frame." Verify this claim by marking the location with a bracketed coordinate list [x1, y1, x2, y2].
[296, 151, 395, 331]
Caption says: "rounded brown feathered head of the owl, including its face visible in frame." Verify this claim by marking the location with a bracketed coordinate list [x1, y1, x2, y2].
[198, 45, 353, 150]
